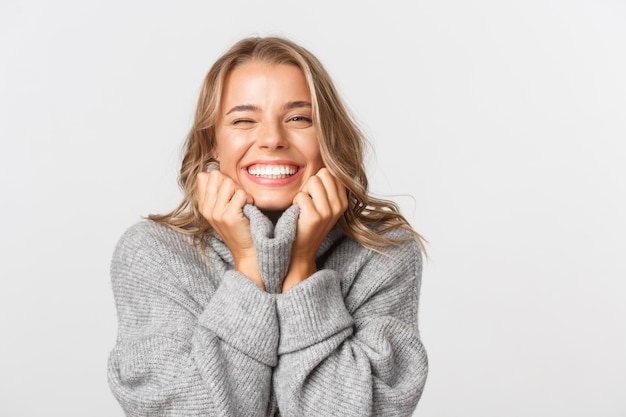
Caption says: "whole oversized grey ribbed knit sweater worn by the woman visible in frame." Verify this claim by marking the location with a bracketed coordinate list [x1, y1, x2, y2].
[108, 205, 428, 417]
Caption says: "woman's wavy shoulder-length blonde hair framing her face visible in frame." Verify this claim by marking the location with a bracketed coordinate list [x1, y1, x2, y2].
[148, 36, 424, 251]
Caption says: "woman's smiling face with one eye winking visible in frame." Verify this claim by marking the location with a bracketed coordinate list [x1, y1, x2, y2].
[215, 62, 323, 210]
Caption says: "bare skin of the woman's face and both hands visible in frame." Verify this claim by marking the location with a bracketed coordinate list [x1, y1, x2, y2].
[197, 62, 348, 292]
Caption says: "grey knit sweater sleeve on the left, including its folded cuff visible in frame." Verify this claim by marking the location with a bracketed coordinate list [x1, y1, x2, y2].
[108, 226, 278, 417]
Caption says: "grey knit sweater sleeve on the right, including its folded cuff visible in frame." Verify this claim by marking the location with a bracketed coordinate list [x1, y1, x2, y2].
[274, 236, 428, 417]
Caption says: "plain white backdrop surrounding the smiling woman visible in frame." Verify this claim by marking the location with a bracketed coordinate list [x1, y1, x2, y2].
[0, 0, 626, 417]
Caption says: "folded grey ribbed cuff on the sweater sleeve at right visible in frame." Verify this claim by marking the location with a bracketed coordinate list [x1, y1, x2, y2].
[276, 269, 354, 355]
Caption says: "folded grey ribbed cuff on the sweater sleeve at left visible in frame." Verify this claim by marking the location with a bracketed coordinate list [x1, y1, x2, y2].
[199, 271, 279, 366]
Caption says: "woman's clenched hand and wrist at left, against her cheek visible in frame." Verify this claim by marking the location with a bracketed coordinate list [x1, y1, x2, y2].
[197, 170, 265, 289]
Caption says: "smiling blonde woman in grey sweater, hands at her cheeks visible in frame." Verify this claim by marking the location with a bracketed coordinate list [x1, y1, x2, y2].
[109, 37, 427, 417]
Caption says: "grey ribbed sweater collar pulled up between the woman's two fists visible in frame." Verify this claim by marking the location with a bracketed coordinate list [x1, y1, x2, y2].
[243, 204, 299, 294]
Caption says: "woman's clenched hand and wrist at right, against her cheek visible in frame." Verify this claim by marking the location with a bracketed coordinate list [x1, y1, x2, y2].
[283, 168, 348, 292]
